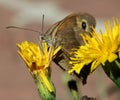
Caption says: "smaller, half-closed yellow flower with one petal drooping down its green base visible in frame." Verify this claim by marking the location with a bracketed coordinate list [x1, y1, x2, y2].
[17, 41, 60, 92]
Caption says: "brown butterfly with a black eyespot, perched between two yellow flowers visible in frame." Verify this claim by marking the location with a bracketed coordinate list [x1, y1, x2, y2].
[41, 13, 96, 83]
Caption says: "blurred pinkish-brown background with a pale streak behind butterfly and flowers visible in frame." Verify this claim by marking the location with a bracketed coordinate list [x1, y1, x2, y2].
[0, 0, 120, 100]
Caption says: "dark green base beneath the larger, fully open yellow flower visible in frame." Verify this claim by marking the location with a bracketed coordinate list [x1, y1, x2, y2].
[102, 58, 120, 88]
